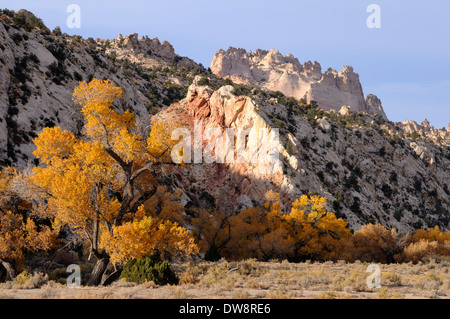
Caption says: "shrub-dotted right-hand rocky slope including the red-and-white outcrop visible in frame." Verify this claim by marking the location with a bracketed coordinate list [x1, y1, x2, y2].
[157, 78, 450, 230]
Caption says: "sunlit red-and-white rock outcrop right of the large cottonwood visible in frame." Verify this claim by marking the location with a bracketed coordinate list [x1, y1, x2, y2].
[156, 77, 285, 211]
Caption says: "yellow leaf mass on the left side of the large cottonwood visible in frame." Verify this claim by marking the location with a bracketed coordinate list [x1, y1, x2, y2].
[30, 132, 119, 228]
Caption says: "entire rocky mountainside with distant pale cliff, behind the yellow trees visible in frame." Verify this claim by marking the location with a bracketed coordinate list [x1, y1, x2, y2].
[0, 8, 450, 230]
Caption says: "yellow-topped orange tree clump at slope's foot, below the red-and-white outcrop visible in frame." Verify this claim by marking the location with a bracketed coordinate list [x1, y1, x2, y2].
[209, 191, 350, 260]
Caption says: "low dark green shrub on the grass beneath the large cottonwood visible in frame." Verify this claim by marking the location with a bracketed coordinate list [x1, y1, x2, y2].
[120, 254, 179, 285]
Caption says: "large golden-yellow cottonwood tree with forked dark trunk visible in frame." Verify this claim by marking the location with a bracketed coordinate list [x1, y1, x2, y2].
[30, 79, 196, 285]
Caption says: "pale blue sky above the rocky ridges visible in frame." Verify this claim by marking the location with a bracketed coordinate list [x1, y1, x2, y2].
[0, 0, 450, 128]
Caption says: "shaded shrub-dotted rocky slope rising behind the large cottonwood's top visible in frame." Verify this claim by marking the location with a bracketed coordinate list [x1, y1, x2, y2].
[0, 11, 204, 167]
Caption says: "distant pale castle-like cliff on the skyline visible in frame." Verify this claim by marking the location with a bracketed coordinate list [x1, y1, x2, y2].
[211, 47, 387, 119]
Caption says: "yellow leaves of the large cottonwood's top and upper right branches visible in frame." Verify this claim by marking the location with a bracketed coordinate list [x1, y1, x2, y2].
[73, 79, 177, 168]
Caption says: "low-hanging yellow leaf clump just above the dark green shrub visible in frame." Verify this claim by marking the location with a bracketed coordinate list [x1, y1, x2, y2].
[101, 206, 198, 263]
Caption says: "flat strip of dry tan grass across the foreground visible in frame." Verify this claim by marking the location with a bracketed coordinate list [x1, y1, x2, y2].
[0, 260, 450, 299]
